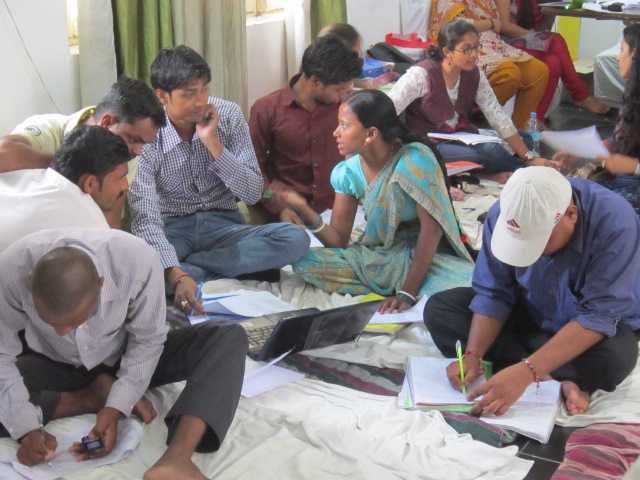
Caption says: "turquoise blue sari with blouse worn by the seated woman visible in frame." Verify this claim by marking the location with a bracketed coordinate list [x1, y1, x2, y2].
[293, 143, 473, 296]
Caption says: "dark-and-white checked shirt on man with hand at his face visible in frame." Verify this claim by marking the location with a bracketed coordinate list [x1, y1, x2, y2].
[129, 97, 264, 268]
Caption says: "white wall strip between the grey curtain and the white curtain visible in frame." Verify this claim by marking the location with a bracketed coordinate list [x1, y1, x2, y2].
[247, 14, 288, 107]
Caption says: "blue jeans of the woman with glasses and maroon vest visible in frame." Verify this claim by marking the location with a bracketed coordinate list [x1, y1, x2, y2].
[437, 142, 524, 173]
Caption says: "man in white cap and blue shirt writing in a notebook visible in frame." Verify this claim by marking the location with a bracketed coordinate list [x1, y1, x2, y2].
[425, 167, 640, 415]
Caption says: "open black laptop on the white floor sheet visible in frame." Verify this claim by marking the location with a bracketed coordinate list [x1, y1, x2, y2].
[237, 302, 381, 360]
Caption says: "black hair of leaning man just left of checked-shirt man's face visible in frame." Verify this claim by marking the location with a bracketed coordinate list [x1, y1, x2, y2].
[96, 76, 166, 127]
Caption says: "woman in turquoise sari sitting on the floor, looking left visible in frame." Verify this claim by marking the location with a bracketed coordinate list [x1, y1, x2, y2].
[285, 90, 473, 311]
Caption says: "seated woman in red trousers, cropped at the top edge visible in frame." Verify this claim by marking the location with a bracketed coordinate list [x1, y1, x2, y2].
[496, 0, 609, 119]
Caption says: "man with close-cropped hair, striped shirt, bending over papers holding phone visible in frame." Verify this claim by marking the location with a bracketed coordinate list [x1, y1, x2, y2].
[0, 229, 247, 480]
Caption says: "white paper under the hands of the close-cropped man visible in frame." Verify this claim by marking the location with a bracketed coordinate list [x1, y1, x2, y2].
[0, 416, 143, 480]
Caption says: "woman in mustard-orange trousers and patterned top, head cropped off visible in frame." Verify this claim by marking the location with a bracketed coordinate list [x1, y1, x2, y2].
[431, 0, 549, 130]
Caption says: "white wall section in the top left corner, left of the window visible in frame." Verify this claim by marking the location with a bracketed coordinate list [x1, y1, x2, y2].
[0, 0, 80, 135]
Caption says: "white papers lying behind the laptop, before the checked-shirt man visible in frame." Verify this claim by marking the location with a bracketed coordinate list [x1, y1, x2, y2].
[189, 290, 296, 325]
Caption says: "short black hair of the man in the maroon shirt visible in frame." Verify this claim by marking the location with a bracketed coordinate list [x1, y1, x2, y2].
[300, 34, 362, 85]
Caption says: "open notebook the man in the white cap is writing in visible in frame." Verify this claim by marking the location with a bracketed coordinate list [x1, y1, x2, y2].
[398, 357, 560, 443]
